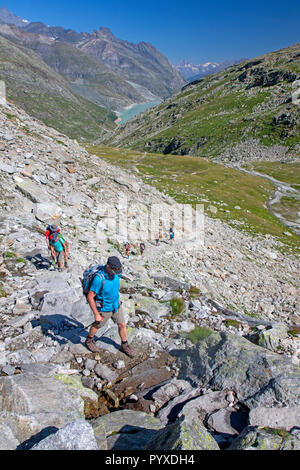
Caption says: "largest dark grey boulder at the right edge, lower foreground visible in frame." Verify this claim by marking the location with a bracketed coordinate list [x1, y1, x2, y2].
[178, 332, 300, 409]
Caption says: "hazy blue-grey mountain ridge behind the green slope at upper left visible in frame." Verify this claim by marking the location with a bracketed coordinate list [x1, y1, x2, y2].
[0, 7, 186, 103]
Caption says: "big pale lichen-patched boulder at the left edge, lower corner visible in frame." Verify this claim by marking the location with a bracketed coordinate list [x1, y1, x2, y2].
[0, 364, 98, 448]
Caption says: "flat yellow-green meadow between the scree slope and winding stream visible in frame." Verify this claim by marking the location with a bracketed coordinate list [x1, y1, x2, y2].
[87, 146, 300, 248]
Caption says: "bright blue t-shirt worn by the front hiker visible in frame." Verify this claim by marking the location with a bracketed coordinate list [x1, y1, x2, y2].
[90, 268, 120, 312]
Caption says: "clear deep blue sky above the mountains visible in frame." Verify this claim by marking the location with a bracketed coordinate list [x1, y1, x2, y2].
[0, 0, 300, 63]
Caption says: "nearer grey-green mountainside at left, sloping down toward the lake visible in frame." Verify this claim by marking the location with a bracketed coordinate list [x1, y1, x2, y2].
[0, 36, 116, 140]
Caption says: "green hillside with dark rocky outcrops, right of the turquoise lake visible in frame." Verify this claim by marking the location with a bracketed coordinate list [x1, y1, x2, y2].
[102, 44, 300, 160]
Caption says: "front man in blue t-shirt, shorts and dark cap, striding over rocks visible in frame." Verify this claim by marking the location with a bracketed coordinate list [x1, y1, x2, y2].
[85, 256, 135, 357]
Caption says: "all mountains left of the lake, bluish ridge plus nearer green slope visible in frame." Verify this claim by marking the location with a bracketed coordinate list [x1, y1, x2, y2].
[0, 7, 186, 141]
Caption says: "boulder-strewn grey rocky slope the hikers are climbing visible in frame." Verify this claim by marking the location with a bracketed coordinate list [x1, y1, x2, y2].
[0, 101, 300, 450]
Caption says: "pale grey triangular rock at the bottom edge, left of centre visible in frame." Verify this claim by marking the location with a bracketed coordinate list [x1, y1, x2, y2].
[31, 419, 98, 450]
